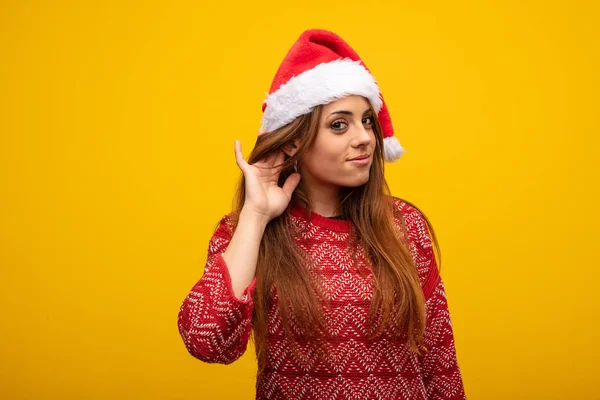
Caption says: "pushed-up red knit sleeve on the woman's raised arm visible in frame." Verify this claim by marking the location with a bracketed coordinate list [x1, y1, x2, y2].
[177, 214, 256, 364]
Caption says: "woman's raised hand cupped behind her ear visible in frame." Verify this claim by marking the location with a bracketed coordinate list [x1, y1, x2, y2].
[234, 133, 300, 223]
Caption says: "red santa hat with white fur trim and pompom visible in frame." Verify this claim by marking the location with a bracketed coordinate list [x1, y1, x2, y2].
[261, 29, 404, 161]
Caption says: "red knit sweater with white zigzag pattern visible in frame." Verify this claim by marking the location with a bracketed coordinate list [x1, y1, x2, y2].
[178, 199, 466, 400]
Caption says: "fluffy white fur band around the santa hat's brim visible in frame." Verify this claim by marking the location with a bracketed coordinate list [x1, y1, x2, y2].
[261, 58, 383, 132]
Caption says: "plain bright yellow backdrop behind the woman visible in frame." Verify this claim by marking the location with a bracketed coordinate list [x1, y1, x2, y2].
[0, 0, 600, 399]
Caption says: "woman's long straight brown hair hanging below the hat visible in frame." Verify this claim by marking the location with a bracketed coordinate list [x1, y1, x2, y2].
[233, 101, 440, 375]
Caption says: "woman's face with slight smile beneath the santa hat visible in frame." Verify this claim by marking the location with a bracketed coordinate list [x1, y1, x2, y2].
[299, 95, 377, 189]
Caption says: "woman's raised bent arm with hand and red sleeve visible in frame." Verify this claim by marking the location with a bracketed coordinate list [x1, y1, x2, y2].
[178, 140, 300, 364]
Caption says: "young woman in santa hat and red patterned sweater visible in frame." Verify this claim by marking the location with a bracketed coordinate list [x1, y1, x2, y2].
[178, 30, 466, 400]
